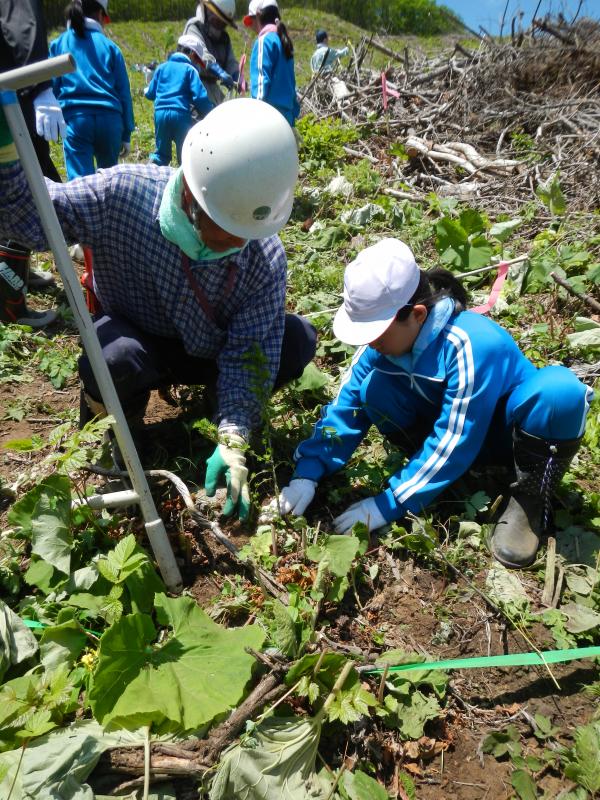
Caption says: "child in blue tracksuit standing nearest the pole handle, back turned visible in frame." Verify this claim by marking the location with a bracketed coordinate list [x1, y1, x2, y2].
[50, 0, 135, 180]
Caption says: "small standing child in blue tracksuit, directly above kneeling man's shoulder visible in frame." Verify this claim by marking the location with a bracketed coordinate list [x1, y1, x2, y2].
[146, 36, 214, 167]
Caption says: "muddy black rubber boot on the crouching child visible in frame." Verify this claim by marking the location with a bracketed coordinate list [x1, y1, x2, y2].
[491, 428, 581, 569]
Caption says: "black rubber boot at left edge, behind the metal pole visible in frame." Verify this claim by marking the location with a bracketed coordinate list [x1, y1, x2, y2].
[0, 244, 56, 328]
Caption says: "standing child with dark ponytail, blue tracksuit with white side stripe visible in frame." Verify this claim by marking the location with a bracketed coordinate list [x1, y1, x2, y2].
[244, 0, 300, 127]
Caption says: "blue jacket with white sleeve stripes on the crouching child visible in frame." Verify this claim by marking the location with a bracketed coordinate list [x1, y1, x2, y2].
[294, 299, 536, 522]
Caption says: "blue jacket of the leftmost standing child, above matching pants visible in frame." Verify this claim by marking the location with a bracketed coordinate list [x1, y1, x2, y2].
[50, 19, 135, 142]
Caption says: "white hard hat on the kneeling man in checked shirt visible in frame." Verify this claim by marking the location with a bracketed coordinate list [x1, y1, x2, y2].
[181, 97, 298, 239]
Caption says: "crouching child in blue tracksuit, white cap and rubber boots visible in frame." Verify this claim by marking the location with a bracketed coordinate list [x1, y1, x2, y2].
[279, 239, 592, 567]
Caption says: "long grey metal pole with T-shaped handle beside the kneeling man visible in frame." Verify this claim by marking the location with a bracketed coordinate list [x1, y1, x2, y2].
[0, 56, 182, 592]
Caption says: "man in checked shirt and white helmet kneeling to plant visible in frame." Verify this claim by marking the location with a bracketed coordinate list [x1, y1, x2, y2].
[0, 99, 316, 518]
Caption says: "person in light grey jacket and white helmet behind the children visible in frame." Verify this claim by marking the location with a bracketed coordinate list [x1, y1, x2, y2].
[183, 0, 239, 105]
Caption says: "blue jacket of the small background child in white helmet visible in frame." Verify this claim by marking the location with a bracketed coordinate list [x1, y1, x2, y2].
[146, 53, 213, 115]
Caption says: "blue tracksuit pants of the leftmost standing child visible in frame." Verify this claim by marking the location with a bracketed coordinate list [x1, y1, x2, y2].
[63, 111, 123, 180]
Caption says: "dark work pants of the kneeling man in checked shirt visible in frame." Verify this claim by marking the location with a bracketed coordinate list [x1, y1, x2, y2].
[79, 314, 317, 416]
